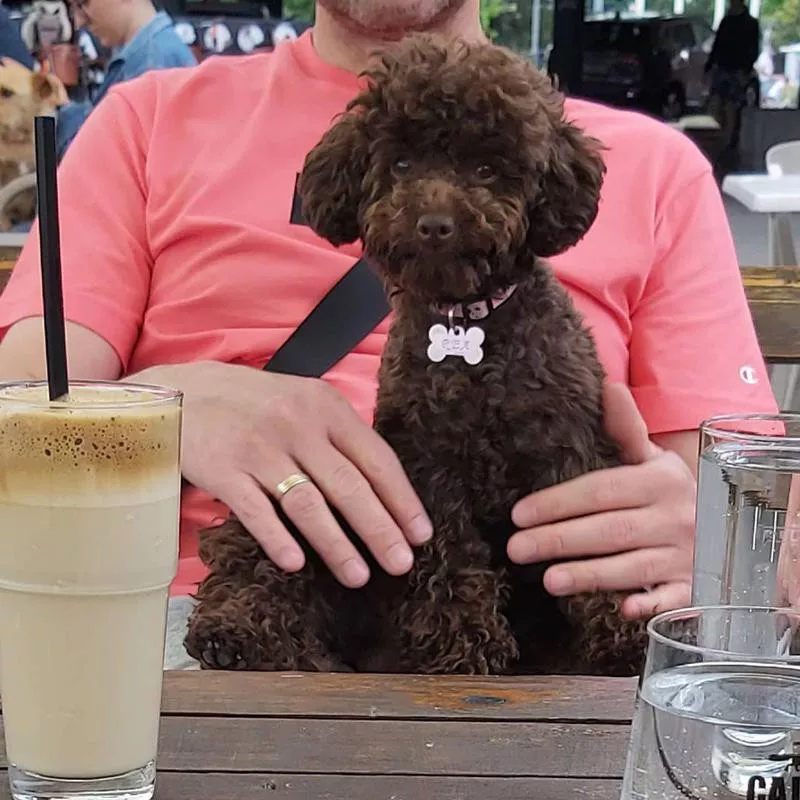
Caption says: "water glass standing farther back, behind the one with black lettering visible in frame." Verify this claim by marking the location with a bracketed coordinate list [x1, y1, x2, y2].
[692, 414, 800, 620]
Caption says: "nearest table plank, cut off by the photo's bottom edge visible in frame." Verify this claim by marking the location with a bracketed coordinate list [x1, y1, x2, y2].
[0, 771, 620, 800]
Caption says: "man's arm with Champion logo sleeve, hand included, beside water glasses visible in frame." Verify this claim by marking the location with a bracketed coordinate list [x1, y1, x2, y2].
[509, 132, 776, 617]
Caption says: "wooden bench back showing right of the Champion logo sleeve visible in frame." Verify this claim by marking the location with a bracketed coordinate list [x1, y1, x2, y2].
[741, 267, 800, 363]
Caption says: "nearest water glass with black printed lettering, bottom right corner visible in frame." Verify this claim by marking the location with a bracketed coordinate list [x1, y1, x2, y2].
[622, 606, 800, 800]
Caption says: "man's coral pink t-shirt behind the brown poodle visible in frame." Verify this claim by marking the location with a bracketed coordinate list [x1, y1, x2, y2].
[0, 33, 774, 593]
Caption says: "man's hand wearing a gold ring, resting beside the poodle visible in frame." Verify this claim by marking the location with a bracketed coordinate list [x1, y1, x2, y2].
[131, 362, 432, 587]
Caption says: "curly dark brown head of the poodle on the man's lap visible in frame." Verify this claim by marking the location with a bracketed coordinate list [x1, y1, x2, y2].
[300, 36, 604, 302]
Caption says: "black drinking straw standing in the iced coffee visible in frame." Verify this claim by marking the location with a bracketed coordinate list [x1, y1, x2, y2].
[34, 116, 69, 400]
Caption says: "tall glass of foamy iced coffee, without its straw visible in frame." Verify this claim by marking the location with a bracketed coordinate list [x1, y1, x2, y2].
[0, 383, 182, 800]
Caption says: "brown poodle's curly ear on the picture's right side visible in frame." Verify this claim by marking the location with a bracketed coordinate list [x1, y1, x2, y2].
[528, 120, 606, 258]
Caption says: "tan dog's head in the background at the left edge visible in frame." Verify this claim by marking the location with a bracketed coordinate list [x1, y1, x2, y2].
[0, 58, 66, 148]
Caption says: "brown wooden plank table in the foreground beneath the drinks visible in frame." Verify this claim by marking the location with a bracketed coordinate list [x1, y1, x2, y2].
[0, 672, 636, 800]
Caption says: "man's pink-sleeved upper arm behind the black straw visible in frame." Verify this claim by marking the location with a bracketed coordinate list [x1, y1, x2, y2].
[0, 84, 153, 366]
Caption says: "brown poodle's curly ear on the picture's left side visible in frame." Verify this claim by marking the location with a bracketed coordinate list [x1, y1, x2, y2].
[298, 111, 369, 247]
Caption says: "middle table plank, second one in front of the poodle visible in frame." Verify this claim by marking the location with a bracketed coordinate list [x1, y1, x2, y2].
[152, 717, 630, 778]
